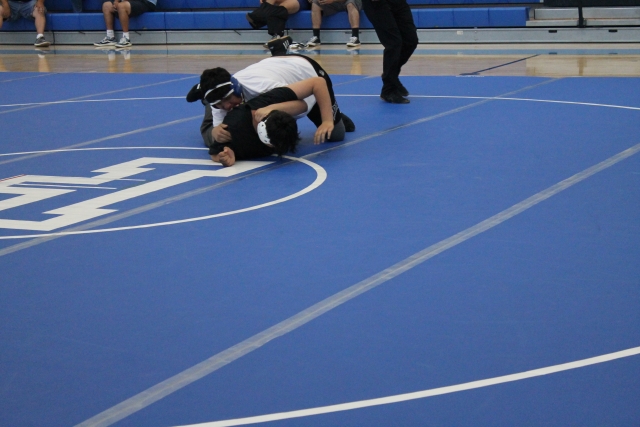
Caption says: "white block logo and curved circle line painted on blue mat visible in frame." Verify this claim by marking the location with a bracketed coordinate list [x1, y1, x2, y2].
[0, 150, 326, 238]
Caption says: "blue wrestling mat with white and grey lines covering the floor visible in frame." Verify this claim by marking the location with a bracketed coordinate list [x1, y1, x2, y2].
[0, 73, 640, 427]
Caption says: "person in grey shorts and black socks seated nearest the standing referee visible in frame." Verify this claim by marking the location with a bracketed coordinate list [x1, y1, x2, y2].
[291, 0, 362, 49]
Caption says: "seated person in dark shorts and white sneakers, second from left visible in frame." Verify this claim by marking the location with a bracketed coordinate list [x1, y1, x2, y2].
[93, 0, 158, 47]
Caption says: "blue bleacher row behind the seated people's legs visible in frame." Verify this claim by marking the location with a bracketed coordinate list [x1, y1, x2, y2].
[2, 0, 528, 31]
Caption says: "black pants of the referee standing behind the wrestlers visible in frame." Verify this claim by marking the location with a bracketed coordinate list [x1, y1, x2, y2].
[362, 0, 418, 95]
